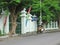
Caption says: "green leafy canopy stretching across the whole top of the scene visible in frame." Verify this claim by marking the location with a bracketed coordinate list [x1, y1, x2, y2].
[0, 0, 60, 22]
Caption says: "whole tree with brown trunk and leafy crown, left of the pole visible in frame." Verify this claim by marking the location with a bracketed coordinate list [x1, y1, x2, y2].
[0, 0, 40, 34]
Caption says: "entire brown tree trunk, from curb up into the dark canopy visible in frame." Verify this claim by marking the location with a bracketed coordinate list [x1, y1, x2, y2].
[9, 7, 18, 35]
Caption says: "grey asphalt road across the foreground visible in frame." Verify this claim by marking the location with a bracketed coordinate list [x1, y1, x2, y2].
[0, 32, 60, 45]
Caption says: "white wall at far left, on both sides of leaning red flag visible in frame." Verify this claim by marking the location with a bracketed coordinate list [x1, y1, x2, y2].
[0, 15, 9, 34]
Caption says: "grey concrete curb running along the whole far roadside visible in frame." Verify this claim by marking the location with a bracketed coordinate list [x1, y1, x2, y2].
[0, 30, 60, 39]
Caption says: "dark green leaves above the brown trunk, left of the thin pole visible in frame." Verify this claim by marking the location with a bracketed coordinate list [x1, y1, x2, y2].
[0, 0, 40, 14]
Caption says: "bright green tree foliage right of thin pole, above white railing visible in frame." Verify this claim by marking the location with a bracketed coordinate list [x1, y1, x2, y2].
[40, 0, 60, 22]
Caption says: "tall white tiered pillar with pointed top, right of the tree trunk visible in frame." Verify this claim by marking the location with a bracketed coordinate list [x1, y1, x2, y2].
[21, 8, 26, 34]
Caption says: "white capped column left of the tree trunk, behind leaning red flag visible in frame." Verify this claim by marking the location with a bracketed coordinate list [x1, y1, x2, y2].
[1, 9, 10, 34]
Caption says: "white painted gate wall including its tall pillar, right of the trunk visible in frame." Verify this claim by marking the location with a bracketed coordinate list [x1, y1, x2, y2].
[21, 9, 37, 34]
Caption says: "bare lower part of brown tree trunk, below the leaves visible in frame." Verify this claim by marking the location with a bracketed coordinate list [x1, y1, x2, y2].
[10, 13, 17, 35]
